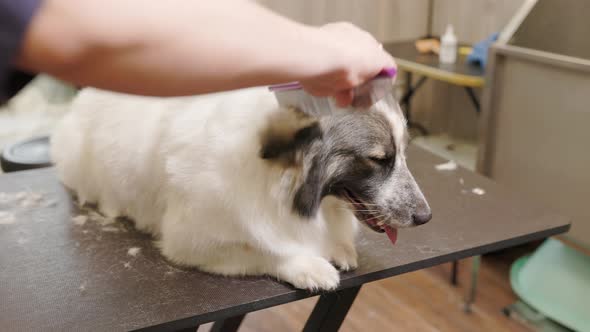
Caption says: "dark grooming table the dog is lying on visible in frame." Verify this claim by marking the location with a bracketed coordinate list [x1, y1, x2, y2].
[0, 147, 569, 331]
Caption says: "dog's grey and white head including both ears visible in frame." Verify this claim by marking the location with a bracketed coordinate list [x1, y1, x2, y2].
[261, 97, 431, 237]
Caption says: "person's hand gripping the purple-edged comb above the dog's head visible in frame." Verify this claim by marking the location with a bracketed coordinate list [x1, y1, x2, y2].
[301, 23, 397, 107]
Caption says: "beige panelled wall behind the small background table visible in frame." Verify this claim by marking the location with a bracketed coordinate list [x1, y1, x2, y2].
[259, 0, 524, 139]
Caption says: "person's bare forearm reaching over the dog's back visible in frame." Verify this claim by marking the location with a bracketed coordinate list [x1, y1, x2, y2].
[19, 0, 380, 95]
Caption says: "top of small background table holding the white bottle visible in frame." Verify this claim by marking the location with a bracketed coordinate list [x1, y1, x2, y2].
[383, 40, 485, 78]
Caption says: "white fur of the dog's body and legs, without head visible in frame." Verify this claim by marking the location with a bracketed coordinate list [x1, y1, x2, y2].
[51, 88, 388, 289]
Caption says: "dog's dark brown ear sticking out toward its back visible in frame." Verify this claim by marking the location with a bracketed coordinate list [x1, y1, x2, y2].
[260, 122, 322, 164]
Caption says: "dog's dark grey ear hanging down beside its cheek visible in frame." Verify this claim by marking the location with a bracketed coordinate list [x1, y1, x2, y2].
[293, 156, 326, 218]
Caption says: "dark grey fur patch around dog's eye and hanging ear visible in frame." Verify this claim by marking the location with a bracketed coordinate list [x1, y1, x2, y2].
[293, 111, 396, 217]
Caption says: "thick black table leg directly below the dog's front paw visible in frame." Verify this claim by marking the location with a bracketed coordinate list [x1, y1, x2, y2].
[303, 286, 361, 332]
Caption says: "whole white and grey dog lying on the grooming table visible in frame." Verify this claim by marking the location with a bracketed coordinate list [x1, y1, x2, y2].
[51, 88, 431, 290]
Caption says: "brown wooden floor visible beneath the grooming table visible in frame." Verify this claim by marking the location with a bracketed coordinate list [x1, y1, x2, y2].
[199, 247, 531, 332]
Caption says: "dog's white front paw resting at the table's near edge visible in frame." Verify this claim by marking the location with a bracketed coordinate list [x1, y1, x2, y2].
[278, 256, 340, 291]
